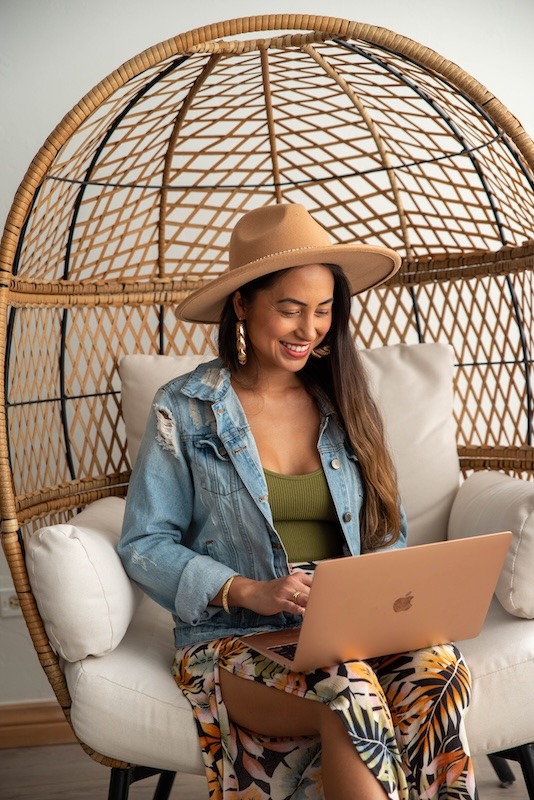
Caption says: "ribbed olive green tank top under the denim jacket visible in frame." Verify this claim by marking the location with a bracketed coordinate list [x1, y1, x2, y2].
[264, 469, 342, 563]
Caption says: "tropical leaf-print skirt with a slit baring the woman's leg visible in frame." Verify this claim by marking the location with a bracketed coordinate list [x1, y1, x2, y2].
[173, 638, 478, 800]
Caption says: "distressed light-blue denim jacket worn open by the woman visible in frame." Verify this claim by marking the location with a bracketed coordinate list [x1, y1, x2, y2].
[118, 360, 406, 647]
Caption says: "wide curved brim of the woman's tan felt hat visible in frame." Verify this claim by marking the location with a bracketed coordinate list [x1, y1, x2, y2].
[176, 244, 401, 323]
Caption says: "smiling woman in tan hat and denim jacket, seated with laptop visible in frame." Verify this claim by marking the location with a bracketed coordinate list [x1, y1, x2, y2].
[119, 204, 476, 800]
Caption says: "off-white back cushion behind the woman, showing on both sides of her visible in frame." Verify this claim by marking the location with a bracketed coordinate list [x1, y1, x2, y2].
[119, 344, 460, 544]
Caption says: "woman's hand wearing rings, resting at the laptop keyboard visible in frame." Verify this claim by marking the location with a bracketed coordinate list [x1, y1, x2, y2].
[220, 570, 313, 616]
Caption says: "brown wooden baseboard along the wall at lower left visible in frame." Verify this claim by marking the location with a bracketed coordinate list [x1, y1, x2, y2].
[0, 701, 76, 750]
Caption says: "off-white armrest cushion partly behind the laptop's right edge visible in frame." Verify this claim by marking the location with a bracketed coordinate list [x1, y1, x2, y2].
[449, 471, 534, 619]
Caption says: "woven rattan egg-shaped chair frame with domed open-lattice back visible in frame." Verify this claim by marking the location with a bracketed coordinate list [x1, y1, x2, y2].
[0, 15, 534, 797]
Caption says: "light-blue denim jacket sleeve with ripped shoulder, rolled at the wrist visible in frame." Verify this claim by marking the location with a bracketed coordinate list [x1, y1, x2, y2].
[118, 378, 241, 626]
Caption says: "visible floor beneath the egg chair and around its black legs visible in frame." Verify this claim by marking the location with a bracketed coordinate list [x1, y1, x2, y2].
[0, 744, 528, 800]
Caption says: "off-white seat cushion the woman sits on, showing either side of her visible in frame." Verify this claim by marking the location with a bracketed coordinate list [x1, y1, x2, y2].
[64, 584, 534, 764]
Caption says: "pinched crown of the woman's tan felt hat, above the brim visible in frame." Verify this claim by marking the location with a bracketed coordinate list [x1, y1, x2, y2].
[229, 203, 332, 270]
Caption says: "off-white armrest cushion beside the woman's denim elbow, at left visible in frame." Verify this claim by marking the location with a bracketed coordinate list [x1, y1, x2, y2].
[26, 497, 136, 661]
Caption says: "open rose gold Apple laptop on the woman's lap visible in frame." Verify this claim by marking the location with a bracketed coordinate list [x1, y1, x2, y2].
[242, 531, 512, 672]
